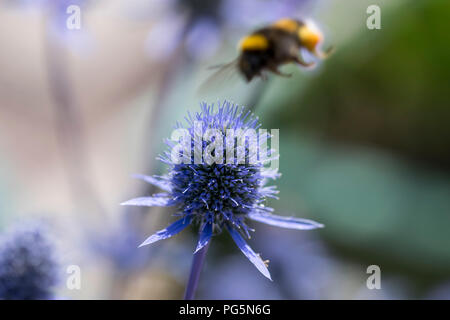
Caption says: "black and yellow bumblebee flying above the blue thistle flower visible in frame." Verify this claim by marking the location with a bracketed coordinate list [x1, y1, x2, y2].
[207, 18, 332, 82]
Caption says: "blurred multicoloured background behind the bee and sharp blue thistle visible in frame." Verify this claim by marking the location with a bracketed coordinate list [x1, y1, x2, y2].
[0, 0, 450, 299]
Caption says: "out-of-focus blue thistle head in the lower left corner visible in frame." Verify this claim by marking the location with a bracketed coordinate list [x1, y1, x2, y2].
[0, 225, 58, 300]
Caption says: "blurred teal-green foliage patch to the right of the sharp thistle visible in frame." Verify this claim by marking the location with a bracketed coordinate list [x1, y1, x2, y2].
[273, 134, 450, 281]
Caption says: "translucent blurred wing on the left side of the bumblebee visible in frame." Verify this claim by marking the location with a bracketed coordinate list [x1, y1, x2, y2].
[197, 59, 239, 95]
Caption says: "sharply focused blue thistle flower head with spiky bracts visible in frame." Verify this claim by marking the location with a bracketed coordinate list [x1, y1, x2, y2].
[122, 102, 323, 279]
